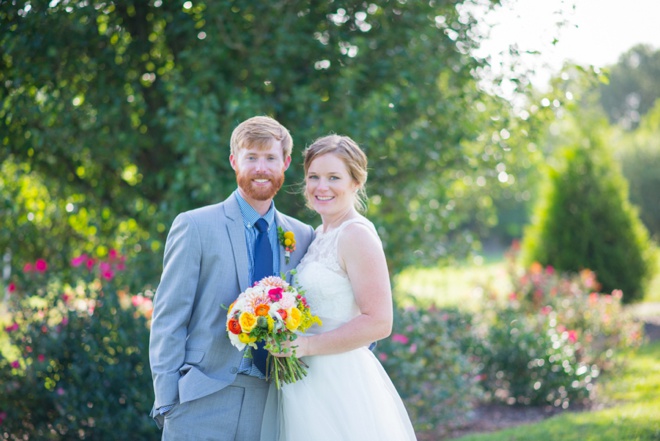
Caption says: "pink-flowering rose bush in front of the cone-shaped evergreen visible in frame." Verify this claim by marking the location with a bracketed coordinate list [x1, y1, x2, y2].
[481, 264, 642, 408]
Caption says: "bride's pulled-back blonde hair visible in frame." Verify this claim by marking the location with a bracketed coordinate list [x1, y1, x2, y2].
[303, 135, 367, 211]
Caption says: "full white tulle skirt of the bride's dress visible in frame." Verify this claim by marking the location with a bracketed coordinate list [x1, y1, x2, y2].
[270, 348, 416, 441]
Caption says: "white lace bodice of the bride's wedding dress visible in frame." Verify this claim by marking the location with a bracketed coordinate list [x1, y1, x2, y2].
[298, 217, 377, 332]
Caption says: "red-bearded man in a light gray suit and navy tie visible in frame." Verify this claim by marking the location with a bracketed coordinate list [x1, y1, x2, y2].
[149, 116, 313, 441]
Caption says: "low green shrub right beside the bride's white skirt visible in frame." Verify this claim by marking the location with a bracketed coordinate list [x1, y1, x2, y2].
[377, 298, 482, 430]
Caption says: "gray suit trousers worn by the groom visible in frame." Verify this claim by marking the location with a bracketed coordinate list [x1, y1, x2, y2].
[162, 374, 275, 441]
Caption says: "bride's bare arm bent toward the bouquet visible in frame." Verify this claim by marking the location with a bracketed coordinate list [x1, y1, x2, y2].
[292, 223, 392, 357]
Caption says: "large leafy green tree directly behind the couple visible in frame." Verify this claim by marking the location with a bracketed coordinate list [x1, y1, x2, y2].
[0, 0, 536, 281]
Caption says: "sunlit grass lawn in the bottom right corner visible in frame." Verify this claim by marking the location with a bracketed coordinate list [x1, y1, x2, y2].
[455, 341, 660, 441]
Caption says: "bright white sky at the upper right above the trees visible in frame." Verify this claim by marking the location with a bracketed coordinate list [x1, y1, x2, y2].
[472, 0, 660, 87]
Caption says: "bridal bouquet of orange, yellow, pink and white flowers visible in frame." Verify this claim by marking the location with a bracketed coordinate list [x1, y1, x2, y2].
[227, 276, 321, 389]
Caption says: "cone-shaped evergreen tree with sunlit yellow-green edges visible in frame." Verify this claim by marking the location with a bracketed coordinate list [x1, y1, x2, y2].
[523, 124, 653, 303]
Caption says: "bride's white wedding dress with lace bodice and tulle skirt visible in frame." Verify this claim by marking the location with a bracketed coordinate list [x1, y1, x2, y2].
[279, 217, 416, 441]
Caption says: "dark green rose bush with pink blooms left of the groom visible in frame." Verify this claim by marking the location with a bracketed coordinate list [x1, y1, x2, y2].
[0, 253, 158, 440]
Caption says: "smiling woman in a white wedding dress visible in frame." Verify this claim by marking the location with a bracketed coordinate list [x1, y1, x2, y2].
[264, 135, 416, 441]
